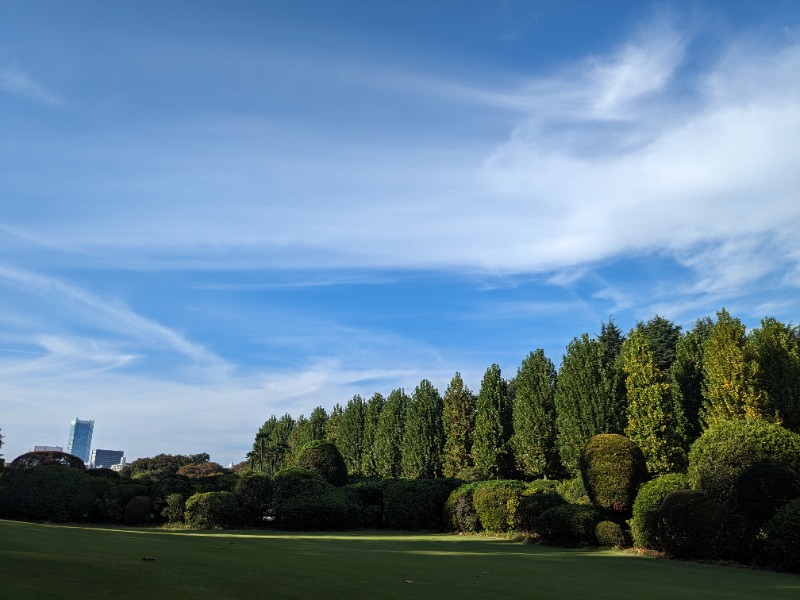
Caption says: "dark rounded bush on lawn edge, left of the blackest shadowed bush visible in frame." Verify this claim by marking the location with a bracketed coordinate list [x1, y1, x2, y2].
[658, 490, 723, 558]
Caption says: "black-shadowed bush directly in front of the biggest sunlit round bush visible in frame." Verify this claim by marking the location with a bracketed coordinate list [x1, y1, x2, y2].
[726, 463, 800, 562]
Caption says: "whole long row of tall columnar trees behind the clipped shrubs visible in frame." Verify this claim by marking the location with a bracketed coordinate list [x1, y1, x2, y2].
[246, 309, 800, 481]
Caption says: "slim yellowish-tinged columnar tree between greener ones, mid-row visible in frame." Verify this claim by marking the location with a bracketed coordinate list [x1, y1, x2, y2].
[442, 373, 475, 477]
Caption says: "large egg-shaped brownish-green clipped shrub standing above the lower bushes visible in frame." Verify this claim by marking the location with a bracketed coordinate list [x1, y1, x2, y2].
[580, 433, 648, 519]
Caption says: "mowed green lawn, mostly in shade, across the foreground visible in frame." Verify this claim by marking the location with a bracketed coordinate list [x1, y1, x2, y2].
[0, 521, 800, 600]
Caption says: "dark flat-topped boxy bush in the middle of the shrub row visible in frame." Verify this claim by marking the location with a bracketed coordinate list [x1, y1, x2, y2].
[383, 479, 454, 530]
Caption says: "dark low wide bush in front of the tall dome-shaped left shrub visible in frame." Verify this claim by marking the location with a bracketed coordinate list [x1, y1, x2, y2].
[276, 487, 360, 531]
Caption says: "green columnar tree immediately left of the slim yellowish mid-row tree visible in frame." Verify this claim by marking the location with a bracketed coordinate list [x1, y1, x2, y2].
[402, 379, 444, 478]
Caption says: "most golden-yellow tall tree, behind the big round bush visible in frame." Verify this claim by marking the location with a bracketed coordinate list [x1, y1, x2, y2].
[702, 308, 775, 427]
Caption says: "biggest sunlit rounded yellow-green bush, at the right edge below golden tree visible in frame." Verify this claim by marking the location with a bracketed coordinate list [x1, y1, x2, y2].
[687, 420, 800, 505]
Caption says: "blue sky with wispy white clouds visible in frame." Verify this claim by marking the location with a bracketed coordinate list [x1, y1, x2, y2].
[0, 0, 800, 464]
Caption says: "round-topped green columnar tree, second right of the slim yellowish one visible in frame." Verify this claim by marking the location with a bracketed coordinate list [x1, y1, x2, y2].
[511, 349, 558, 479]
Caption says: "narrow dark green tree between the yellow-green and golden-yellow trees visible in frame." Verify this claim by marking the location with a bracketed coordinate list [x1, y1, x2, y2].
[669, 317, 713, 444]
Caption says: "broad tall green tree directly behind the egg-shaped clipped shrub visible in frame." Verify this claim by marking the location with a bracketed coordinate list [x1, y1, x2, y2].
[555, 333, 625, 474]
